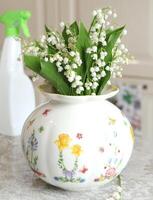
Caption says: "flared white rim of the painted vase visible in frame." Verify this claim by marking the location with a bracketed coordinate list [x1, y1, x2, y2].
[38, 85, 119, 103]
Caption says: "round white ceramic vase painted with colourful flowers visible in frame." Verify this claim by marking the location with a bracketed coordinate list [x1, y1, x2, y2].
[22, 88, 134, 191]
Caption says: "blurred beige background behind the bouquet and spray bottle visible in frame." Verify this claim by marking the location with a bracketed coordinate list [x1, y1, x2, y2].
[0, 0, 153, 141]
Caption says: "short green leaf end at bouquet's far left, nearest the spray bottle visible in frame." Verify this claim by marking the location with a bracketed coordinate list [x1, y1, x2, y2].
[24, 55, 41, 74]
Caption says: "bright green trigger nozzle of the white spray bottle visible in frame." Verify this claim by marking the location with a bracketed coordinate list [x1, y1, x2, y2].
[0, 10, 31, 37]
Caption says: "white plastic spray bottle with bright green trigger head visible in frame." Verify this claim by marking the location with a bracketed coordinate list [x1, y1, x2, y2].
[0, 11, 35, 136]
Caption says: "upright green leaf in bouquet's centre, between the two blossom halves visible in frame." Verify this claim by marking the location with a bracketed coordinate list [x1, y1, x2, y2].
[76, 22, 92, 82]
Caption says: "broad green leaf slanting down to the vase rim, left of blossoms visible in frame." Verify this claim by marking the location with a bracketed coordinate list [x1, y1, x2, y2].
[40, 61, 70, 95]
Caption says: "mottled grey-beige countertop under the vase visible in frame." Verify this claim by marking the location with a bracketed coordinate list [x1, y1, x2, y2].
[0, 134, 153, 200]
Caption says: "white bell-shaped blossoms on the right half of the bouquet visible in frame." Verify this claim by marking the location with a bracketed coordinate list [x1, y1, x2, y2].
[86, 8, 128, 90]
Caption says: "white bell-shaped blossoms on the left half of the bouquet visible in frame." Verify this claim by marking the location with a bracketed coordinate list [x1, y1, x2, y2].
[24, 29, 84, 94]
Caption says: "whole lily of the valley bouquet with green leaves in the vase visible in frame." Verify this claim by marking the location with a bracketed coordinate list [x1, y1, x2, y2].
[24, 8, 129, 95]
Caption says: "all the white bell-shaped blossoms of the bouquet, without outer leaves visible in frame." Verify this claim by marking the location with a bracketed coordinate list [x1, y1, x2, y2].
[24, 8, 128, 95]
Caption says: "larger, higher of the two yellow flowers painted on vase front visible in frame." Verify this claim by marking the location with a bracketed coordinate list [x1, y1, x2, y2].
[55, 133, 72, 151]
